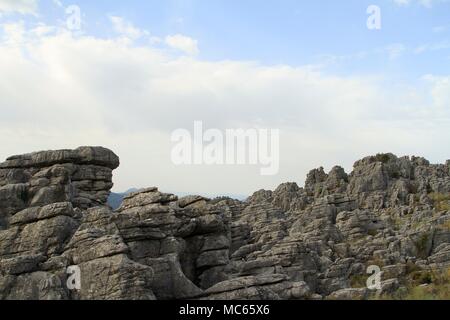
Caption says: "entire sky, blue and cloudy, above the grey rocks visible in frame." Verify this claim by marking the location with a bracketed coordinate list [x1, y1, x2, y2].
[0, 0, 450, 196]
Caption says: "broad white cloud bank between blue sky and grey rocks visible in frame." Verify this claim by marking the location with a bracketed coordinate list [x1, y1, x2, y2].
[0, 23, 450, 194]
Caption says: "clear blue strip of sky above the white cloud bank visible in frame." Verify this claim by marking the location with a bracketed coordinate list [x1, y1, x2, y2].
[5, 0, 450, 77]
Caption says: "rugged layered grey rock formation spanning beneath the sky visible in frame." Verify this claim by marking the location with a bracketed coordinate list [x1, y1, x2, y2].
[0, 147, 450, 299]
